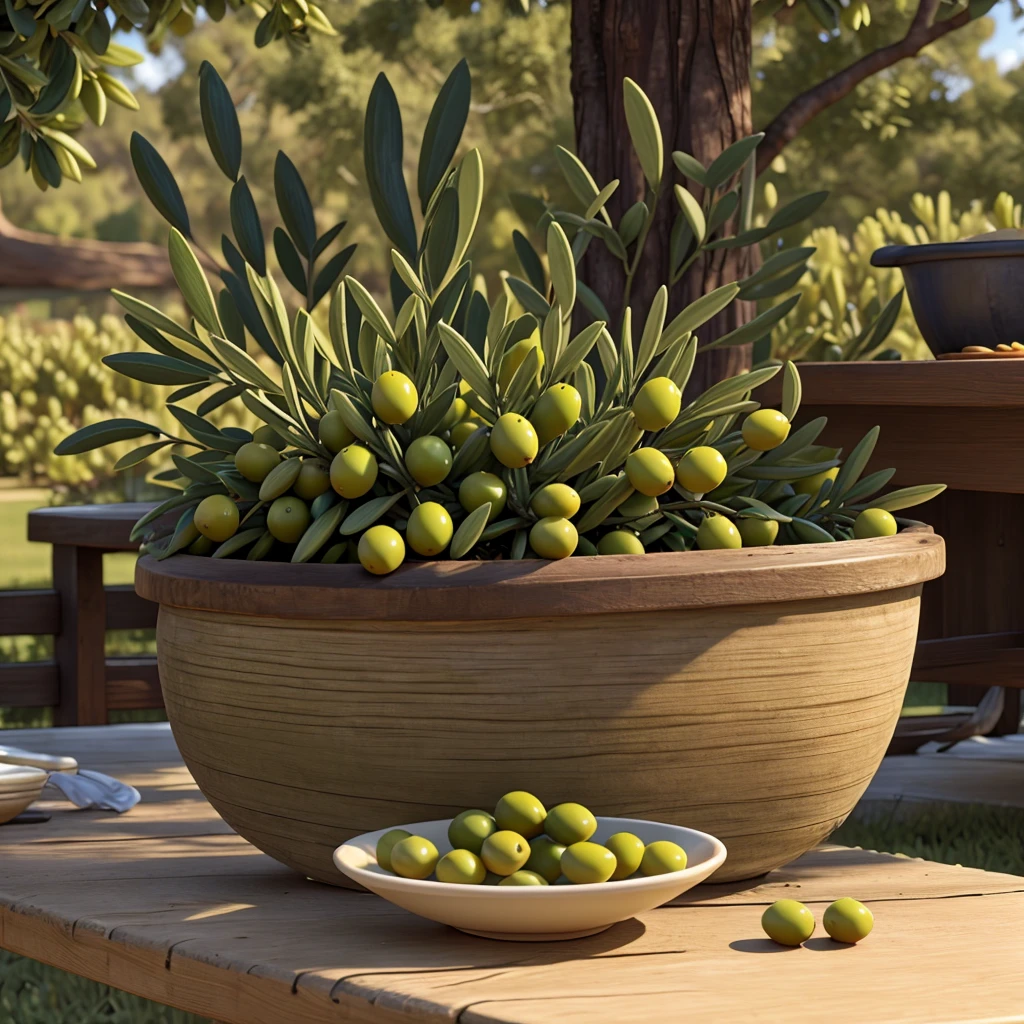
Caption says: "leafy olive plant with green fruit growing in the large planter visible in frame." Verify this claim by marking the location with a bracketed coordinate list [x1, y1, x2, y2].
[57, 62, 942, 572]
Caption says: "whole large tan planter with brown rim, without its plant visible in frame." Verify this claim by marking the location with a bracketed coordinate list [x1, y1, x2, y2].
[137, 531, 943, 885]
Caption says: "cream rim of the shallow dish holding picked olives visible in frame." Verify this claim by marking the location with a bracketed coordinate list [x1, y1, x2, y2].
[331, 814, 728, 899]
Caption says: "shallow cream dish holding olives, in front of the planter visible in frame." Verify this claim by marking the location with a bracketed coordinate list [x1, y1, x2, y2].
[334, 818, 726, 942]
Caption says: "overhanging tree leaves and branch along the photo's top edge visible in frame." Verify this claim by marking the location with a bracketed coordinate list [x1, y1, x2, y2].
[0, 0, 1007, 190]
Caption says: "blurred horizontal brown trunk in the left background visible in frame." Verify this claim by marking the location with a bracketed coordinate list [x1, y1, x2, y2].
[0, 193, 176, 292]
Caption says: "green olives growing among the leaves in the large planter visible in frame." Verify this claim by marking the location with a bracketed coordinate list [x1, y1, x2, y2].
[188, 356, 897, 574]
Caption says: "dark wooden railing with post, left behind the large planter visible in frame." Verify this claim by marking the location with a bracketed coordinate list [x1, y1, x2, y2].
[0, 504, 163, 725]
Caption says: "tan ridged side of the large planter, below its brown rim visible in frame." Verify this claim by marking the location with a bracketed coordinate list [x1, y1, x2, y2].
[158, 584, 921, 884]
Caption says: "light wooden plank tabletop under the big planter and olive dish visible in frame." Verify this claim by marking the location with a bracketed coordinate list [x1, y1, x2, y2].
[0, 725, 1024, 1024]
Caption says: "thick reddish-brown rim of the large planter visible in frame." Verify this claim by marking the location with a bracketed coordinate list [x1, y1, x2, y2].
[135, 527, 944, 622]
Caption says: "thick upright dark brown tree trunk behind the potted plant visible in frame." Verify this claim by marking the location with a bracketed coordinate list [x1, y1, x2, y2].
[572, 0, 757, 393]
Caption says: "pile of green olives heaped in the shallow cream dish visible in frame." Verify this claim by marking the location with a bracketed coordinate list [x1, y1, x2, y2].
[376, 790, 686, 886]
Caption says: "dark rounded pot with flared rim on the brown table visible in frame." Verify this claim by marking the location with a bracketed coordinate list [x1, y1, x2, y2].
[871, 239, 1024, 355]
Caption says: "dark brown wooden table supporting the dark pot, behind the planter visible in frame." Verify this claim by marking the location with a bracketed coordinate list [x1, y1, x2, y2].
[756, 358, 1024, 733]
